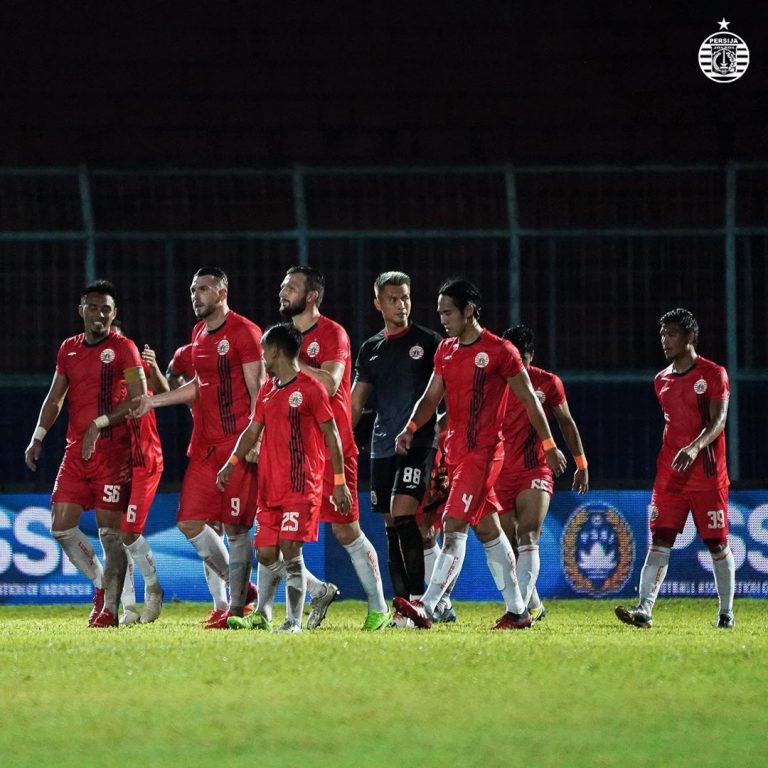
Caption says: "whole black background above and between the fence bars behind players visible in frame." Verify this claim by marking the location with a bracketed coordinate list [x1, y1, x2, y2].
[0, 0, 768, 491]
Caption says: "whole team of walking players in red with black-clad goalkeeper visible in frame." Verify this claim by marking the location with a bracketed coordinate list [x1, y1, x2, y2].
[25, 266, 735, 633]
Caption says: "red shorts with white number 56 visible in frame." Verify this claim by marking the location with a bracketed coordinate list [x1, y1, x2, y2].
[51, 443, 131, 512]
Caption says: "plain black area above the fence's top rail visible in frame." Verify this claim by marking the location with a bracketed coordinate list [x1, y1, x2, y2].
[0, 0, 768, 167]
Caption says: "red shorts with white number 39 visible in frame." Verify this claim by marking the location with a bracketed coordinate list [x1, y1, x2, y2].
[650, 486, 728, 544]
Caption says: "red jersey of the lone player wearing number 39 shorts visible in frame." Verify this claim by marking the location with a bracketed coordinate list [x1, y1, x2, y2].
[653, 355, 730, 491]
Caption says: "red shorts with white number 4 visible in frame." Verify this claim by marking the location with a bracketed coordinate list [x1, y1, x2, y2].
[445, 453, 502, 525]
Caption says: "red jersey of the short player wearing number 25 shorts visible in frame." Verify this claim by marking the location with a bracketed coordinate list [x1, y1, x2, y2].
[253, 371, 333, 507]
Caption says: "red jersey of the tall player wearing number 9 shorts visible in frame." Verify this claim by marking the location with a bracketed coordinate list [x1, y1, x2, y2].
[190, 311, 261, 451]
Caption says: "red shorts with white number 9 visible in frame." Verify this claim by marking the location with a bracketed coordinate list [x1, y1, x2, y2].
[177, 438, 258, 528]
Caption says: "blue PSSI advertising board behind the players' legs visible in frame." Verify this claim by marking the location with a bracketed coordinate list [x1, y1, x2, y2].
[0, 491, 768, 604]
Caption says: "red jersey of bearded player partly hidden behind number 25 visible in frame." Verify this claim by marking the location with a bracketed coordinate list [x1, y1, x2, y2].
[299, 315, 358, 457]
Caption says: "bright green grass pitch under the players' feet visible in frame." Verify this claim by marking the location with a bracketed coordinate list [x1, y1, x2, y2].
[0, 599, 768, 768]
